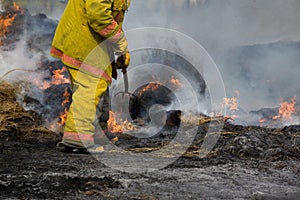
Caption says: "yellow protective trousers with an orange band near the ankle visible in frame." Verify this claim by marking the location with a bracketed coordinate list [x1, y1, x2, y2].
[62, 67, 109, 147]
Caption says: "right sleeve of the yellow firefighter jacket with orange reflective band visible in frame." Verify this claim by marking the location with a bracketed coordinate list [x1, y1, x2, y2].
[86, 0, 128, 54]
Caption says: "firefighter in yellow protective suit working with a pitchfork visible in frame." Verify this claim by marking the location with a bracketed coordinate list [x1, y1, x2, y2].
[50, 0, 130, 153]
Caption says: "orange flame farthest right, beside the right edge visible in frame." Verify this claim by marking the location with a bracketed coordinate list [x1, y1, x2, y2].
[273, 97, 297, 120]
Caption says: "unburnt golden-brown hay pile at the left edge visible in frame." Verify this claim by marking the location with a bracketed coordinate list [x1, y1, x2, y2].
[0, 81, 60, 142]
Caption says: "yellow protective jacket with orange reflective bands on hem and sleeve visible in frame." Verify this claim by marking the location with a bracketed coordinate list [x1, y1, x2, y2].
[50, 0, 130, 82]
